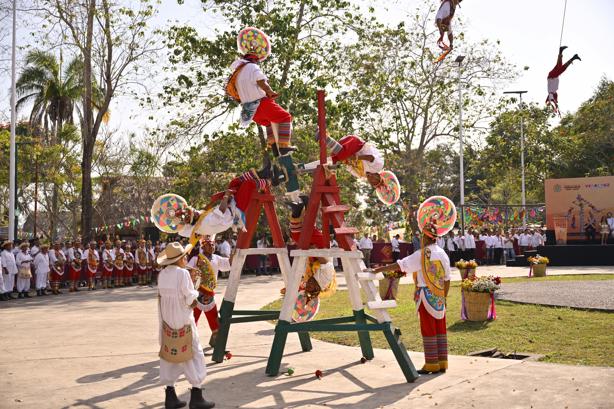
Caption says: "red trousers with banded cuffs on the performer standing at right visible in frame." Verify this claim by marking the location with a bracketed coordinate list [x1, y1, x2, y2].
[418, 303, 448, 372]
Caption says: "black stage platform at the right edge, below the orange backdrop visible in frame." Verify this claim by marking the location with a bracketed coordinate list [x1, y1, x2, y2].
[523, 244, 614, 266]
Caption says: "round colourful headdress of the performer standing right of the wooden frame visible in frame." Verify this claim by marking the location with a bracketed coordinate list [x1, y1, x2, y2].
[417, 196, 456, 239]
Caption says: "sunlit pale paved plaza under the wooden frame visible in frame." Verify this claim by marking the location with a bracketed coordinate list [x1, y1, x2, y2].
[0, 267, 614, 409]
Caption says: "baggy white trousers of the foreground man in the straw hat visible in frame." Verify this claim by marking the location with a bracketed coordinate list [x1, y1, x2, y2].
[160, 324, 207, 388]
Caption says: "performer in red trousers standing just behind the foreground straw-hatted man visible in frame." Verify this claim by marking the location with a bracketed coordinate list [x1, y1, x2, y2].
[188, 236, 230, 347]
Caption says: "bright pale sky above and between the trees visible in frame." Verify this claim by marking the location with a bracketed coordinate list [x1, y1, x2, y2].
[0, 0, 614, 133]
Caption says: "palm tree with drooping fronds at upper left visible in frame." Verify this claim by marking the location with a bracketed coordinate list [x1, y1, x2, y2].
[16, 50, 83, 240]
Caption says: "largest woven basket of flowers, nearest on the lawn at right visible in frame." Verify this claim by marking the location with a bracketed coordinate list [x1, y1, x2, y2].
[461, 276, 501, 321]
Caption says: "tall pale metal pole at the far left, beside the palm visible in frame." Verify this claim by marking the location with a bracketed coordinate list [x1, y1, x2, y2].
[8, 0, 17, 241]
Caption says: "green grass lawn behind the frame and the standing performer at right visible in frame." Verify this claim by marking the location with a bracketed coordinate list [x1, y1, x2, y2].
[264, 274, 614, 366]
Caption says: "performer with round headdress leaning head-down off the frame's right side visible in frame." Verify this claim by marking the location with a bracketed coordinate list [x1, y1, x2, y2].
[298, 134, 401, 206]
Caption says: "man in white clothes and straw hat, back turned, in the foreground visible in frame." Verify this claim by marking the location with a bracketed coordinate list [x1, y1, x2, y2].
[157, 242, 215, 409]
